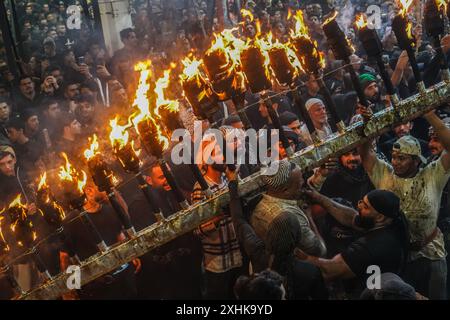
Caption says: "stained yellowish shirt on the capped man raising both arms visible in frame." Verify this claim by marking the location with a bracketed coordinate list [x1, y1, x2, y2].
[369, 158, 450, 260]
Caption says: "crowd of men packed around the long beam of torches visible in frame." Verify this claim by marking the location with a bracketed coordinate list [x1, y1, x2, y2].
[0, 0, 450, 300]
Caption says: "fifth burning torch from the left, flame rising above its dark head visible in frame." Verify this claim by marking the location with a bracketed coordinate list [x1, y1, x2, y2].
[84, 134, 136, 238]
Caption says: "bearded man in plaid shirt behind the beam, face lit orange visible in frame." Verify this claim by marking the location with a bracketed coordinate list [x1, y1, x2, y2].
[192, 134, 242, 299]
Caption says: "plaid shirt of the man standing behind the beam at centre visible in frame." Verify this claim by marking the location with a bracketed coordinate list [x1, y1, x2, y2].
[192, 177, 242, 273]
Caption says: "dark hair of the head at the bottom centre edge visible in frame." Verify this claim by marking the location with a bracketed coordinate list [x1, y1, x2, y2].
[234, 270, 283, 300]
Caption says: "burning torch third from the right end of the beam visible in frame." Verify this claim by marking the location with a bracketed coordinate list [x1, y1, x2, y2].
[356, 14, 399, 107]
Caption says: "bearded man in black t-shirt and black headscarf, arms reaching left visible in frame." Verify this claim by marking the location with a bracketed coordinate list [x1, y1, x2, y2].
[297, 190, 409, 296]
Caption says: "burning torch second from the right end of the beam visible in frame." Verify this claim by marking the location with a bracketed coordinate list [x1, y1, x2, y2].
[392, 0, 425, 93]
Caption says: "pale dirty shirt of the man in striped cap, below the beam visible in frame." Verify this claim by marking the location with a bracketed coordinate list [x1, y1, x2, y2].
[251, 194, 326, 256]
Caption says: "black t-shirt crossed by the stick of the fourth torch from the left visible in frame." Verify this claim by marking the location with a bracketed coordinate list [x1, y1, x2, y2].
[65, 203, 122, 260]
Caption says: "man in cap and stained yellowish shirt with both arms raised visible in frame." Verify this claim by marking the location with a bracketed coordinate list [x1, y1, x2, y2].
[359, 111, 450, 299]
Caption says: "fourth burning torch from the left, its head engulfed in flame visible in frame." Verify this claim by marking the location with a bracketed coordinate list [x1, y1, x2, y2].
[58, 152, 108, 252]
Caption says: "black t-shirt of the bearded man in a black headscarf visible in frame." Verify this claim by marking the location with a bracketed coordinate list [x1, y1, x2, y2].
[341, 226, 405, 283]
